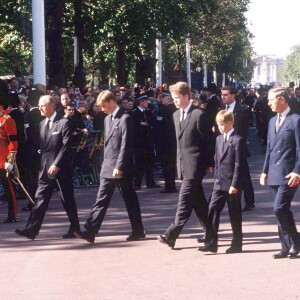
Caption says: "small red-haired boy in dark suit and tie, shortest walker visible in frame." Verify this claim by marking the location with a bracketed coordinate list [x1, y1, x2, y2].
[198, 110, 246, 253]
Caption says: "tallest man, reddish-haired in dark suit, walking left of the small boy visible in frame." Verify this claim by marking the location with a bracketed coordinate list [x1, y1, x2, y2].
[157, 82, 213, 248]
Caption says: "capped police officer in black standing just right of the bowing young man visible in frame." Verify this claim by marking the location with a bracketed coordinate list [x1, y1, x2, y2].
[132, 95, 159, 190]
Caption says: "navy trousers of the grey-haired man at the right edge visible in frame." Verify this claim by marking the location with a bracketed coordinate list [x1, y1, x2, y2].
[271, 185, 299, 252]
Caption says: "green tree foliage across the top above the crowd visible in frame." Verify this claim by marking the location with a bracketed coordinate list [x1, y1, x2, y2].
[0, 0, 253, 84]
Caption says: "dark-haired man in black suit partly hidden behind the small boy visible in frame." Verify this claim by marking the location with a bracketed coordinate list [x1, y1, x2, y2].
[221, 86, 255, 211]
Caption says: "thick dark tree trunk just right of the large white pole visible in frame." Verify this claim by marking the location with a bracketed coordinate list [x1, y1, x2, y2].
[46, 0, 66, 86]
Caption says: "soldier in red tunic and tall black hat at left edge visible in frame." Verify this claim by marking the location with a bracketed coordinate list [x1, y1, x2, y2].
[0, 81, 18, 223]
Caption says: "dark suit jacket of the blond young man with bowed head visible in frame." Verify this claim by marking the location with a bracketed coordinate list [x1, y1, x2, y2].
[100, 109, 134, 179]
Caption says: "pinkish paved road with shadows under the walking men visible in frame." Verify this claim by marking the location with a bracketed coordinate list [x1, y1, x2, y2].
[0, 132, 300, 300]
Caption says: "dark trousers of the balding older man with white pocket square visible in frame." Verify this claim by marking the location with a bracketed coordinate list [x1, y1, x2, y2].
[25, 174, 80, 236]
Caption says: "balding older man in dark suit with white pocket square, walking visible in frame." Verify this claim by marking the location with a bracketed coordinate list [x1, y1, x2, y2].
[15, 95, 80, 240]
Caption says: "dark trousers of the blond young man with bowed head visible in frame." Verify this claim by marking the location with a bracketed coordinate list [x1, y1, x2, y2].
[84, 178, 144, 235]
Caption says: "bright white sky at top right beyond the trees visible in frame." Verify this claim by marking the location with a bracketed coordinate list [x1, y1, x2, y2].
[247, 0, 300, 58]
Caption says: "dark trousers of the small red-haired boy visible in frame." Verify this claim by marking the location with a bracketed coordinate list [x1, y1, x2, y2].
[208, 190, 243, 247]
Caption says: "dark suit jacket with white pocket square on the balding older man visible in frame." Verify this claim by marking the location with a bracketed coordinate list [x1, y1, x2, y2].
[39, 114, 72, 179]
